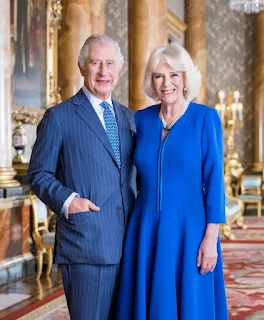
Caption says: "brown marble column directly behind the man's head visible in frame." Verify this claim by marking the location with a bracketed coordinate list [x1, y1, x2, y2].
[58, 0, 104, 100]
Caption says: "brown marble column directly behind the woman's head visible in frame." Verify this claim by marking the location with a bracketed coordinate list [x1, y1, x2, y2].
[128, 0, 168, 111]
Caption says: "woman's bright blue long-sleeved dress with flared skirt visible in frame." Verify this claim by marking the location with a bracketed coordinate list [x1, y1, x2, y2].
[117, 103, 228, 320]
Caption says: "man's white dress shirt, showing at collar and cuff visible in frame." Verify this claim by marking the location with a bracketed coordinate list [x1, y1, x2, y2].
[61, 85, 115, 219]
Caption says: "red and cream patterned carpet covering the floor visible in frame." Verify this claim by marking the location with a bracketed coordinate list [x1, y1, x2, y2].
[19, 217, 264, 320]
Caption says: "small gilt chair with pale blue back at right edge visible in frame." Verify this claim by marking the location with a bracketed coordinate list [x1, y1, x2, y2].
[238, 175, 262, 217]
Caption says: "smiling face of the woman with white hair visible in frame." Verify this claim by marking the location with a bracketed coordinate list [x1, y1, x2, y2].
[152, 61, 184, 104]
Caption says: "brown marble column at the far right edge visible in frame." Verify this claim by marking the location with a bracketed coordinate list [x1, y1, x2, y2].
[253, 11, 264, 171]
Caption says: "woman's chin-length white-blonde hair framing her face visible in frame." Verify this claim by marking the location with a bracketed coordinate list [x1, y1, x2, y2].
[143, 42, 201, 101]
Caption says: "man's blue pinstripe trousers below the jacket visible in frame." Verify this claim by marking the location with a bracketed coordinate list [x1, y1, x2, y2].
[62, 264, 119, 320]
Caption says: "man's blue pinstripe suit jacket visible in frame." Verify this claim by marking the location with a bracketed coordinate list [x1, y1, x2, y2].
[28, 89, 136, 264]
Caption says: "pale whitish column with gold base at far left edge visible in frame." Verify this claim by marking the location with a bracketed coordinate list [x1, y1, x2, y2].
[0, 1, 20, 188]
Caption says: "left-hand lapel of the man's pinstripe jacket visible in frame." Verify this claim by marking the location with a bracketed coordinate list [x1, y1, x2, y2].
[73, 89, 117, 164]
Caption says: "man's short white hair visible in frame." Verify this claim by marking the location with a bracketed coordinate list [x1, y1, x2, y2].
[78, 34, 124, 70]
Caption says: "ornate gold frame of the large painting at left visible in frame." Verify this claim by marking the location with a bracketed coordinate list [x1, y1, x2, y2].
[12, 0, 62, 124]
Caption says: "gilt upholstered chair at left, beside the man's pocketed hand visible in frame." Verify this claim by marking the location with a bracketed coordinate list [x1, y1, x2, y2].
[27, 196, 55, 279]
